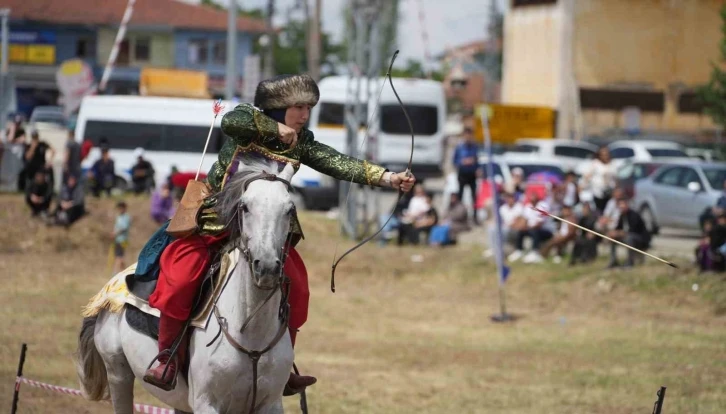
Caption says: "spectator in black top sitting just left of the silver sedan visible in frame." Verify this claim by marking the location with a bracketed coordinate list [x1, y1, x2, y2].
[608, 198, 650, 268]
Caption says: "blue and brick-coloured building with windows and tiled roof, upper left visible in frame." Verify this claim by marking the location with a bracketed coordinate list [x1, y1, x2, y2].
[3, 0, 265, 114]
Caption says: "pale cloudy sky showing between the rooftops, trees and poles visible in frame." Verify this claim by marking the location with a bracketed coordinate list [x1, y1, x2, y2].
[196, 0, 507, 63]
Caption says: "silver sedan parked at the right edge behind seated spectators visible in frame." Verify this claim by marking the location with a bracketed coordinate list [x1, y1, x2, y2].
[633, 161, 726, 233]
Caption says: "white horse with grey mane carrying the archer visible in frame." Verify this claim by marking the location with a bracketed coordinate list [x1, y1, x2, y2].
[77, 163, 294, 414]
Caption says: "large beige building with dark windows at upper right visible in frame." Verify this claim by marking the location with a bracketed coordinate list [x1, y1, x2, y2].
[502, 0, 724, 142]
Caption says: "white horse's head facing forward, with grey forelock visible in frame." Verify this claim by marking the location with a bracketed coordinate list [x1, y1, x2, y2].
[220, 164, 295, 288]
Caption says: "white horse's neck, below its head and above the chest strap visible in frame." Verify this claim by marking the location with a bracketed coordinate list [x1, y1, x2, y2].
[217, 256, 280, 347]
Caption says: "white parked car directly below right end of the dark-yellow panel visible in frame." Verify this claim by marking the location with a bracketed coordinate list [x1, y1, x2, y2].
[508, 138, 598, 171]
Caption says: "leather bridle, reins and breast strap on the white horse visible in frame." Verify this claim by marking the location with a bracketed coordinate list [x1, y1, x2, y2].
[207, 172, 292, 413]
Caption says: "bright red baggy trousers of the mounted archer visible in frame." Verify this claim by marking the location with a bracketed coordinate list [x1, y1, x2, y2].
[149, 234, 310, 344]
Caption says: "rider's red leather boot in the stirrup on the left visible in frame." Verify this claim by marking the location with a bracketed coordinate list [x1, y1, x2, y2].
[144, 315, 187, 391]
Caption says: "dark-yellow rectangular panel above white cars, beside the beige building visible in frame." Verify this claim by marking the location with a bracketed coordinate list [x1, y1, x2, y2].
[474, 104, 555, 145]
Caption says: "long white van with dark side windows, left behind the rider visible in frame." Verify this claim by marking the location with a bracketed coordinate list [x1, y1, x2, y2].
[75, 96, 324, 202]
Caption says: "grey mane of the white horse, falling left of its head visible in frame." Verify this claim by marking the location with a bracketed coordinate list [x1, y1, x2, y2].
[214, 157, 280, 230]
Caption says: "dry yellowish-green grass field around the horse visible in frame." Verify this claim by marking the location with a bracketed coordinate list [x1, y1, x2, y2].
[0, 196, 726, 414]
